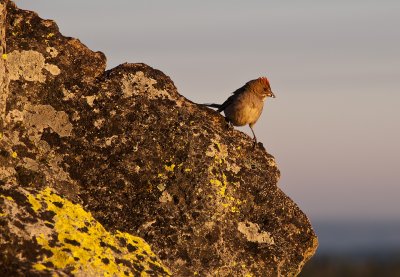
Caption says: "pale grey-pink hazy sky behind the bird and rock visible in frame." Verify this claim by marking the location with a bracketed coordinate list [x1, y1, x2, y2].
[15, 0, 400, 226]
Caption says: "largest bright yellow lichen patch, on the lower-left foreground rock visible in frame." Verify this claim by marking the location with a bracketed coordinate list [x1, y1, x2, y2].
[28, 188, 171, 276]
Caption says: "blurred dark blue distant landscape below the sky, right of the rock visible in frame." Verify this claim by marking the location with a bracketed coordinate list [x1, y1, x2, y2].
[300, 220, 400, 277]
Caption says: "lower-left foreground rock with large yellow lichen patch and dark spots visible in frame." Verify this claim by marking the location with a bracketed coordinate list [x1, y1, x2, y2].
[0, 188, 170, 276]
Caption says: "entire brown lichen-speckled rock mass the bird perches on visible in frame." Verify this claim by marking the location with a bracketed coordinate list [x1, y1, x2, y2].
[0, 1, 318, 276]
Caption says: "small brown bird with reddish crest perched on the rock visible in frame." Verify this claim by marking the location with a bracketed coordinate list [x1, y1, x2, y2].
[203, 77, 275, 146]
